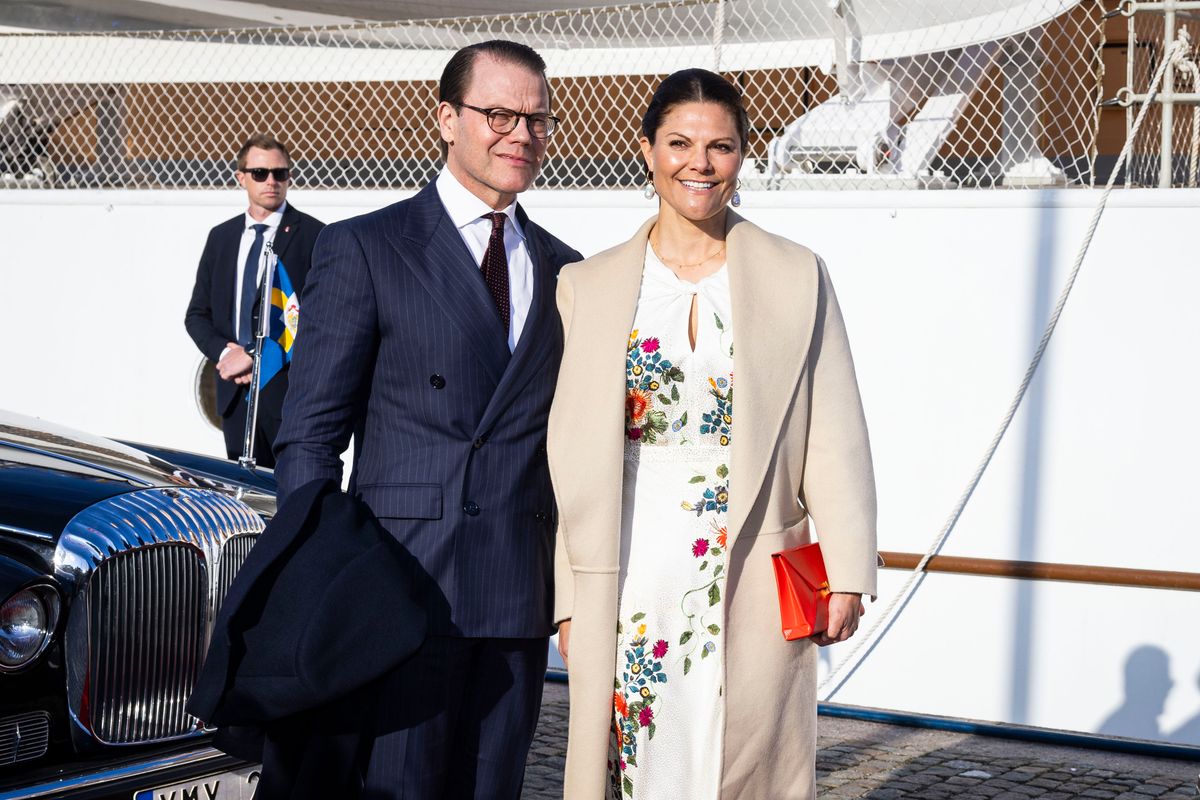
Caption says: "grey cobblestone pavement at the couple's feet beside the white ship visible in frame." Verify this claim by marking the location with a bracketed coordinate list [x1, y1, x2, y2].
[522, 684, 1200, 800]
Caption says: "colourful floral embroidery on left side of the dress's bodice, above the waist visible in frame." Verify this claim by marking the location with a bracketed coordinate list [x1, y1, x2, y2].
[625, 329, 688, 445]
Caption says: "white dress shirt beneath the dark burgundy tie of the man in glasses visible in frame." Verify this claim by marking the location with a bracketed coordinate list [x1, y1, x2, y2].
[437, 169, 533, 353]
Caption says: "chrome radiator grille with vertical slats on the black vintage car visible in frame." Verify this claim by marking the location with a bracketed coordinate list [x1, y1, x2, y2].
[55, 488, 263, 745]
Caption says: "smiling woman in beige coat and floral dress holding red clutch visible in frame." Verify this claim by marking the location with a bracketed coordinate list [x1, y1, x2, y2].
[547, 70, 876, 800]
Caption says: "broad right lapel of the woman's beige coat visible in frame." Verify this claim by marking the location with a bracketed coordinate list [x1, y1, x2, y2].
[726, 211, 818, 548]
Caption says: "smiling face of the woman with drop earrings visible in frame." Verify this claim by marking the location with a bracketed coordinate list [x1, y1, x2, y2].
[641, 102, 743, 222]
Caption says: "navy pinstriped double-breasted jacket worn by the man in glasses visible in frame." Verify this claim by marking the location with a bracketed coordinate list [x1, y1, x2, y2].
[276, 186, 580, 637]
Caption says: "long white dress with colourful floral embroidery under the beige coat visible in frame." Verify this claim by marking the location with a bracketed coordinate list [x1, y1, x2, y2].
[610, 247, 733, 800]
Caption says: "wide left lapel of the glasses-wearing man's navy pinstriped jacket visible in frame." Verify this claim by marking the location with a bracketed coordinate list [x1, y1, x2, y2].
[388, 184, 510, 383]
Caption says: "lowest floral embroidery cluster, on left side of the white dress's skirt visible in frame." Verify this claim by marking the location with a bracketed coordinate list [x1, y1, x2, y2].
[612, 612, 671, 796]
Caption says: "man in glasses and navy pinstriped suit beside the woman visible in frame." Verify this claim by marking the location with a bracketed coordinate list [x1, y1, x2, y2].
[276, 41, 580, 800]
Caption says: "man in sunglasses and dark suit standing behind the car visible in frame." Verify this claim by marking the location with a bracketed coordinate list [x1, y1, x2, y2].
[184, 133, 324, 467]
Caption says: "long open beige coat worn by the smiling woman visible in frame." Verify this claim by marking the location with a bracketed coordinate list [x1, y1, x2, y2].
[547, 211, 876, 800]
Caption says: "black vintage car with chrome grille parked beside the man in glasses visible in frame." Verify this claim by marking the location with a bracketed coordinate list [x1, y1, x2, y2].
[0, 413, 275, 800]
